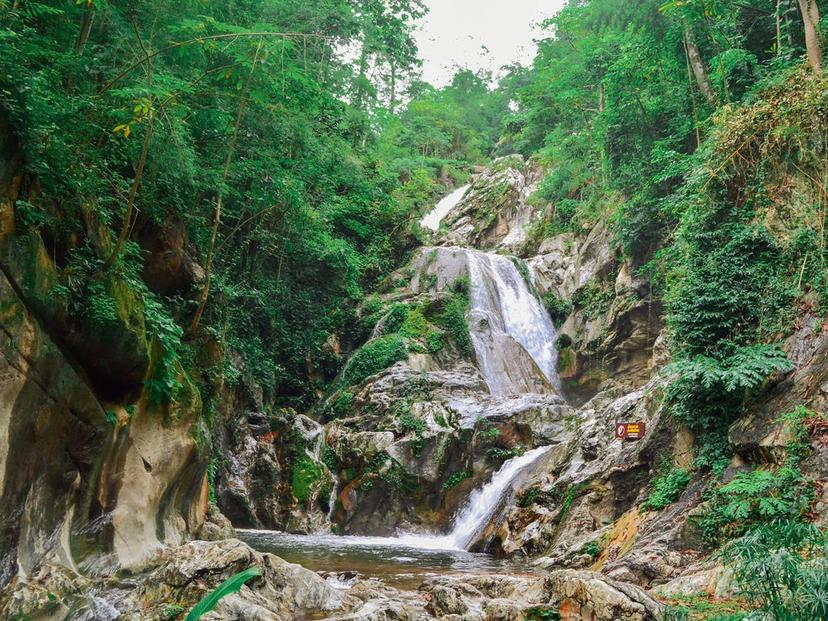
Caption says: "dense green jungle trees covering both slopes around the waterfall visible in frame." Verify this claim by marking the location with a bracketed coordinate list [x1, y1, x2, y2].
[0, 0, 828, 436]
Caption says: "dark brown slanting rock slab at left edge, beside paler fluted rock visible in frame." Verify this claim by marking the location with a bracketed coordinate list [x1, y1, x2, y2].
[0, 274, 115, 587]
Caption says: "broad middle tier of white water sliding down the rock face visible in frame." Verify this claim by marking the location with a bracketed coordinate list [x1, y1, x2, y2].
[466, 250, 559, 395]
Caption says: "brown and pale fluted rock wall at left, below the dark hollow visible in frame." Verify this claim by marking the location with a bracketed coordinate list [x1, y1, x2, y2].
[0, 266, 207, 584]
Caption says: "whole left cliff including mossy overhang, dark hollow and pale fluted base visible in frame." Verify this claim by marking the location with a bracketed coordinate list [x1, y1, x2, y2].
[0, 130, 209, 588]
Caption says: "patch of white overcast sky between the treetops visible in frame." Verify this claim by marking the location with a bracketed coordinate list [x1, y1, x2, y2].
[416, 0, 565, 86]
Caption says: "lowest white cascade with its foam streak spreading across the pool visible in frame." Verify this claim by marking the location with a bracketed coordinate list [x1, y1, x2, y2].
[240, 446, 549, 551]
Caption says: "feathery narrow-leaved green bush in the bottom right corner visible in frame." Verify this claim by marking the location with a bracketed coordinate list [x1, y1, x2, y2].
[721, 521, 828, 621]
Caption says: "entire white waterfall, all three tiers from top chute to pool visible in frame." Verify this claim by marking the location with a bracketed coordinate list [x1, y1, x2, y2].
[241, 191, 559, 551]
